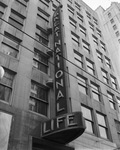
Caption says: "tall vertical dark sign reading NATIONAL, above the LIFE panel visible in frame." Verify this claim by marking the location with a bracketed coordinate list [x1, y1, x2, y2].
[53, 5, 67, 116]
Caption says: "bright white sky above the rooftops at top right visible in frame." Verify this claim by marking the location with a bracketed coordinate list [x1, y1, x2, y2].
[83, 0, 120, 10]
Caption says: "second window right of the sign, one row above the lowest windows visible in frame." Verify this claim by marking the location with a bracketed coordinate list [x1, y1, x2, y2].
[91, 82, 100, 101]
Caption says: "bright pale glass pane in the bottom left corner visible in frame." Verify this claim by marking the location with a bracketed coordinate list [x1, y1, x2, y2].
[0, 112, 12, 150]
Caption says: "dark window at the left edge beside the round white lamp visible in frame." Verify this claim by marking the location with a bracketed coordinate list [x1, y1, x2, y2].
[0, 69, 15, 103]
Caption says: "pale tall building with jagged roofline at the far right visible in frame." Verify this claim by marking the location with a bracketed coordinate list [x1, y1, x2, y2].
[96, 2, 120, 85]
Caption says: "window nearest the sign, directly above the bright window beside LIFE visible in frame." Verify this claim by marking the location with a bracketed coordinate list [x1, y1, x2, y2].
[77, 74, 88, 95]
